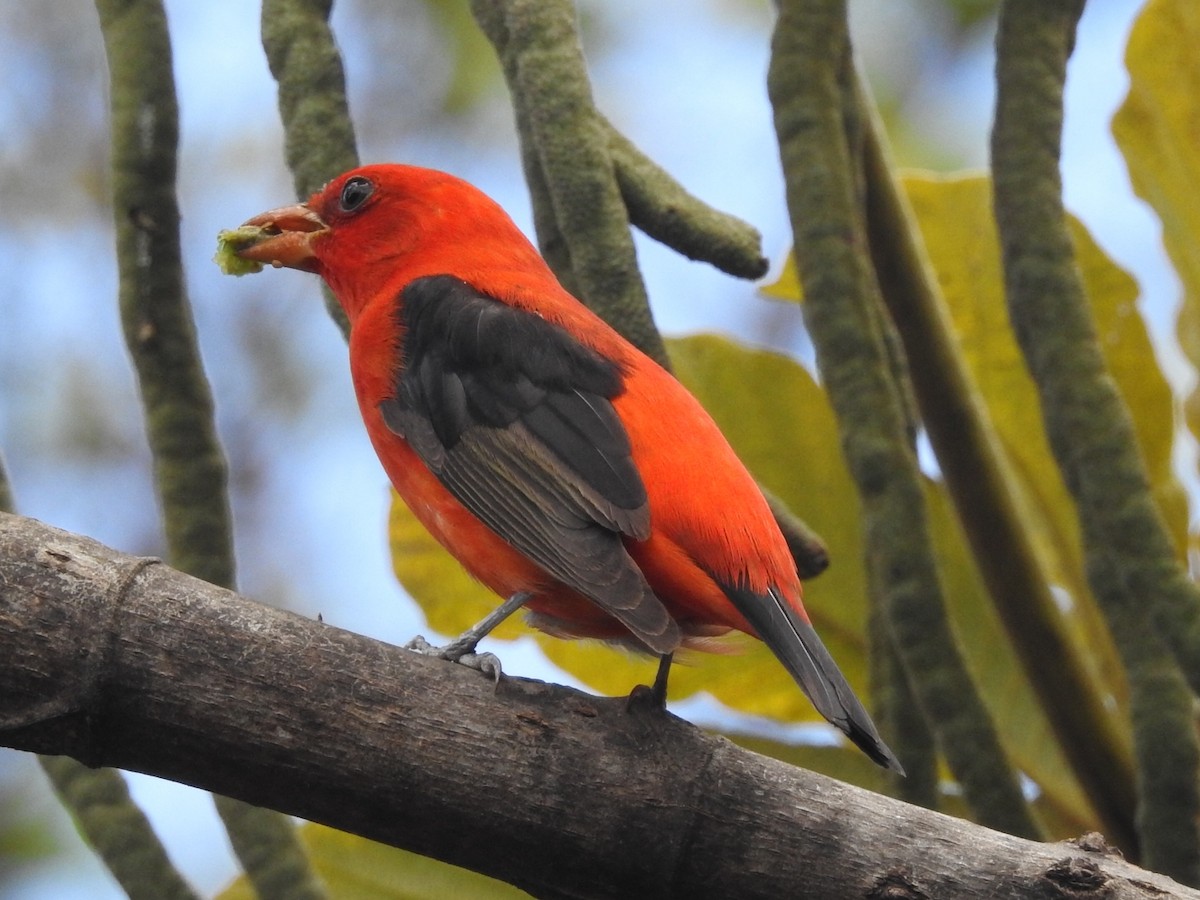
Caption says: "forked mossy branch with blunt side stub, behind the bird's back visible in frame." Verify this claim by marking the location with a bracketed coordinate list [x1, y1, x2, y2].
[470, 0, 828, 577]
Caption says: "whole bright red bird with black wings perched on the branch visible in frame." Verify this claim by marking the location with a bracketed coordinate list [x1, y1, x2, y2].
[238, 160, 901, 772]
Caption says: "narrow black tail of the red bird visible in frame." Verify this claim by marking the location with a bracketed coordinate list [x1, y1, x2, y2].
[725, 588, 904, 775]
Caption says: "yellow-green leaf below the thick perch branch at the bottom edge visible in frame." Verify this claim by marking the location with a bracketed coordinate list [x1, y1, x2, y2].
[218, 823, 529, 900]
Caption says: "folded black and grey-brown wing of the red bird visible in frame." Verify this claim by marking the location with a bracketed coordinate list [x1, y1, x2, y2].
[380, 275, 679, 654]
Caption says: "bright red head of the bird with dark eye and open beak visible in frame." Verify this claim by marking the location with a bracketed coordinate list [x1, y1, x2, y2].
[236, 164, 541, 322]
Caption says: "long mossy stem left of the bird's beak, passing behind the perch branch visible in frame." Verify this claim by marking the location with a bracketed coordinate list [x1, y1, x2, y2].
[96, 0, 320, 898]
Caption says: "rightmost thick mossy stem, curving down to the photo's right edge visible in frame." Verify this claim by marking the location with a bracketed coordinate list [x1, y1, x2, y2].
[991, 0, 1200, 692]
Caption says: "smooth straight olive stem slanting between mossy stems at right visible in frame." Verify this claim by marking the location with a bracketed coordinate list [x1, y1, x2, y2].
[858, 77, 1138, 854]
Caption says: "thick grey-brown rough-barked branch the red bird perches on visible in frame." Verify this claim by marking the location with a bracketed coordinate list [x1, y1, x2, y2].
[0, 514, 1200, 899]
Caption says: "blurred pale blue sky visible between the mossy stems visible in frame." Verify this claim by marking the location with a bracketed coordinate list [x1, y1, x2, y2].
[0, 0, 1161, 900]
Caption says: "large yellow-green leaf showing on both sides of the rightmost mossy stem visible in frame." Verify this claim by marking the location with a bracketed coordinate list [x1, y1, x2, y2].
[905, 175, 1187, 681]
